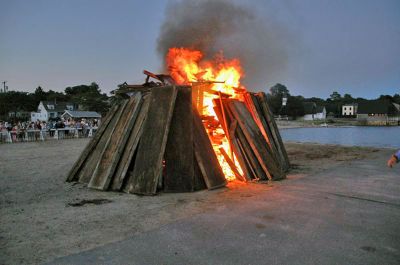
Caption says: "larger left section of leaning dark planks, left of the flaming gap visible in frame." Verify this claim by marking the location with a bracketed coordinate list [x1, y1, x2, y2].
[67, 86, 226, 195]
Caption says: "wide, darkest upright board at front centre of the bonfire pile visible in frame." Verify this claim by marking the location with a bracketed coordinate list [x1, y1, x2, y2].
[163, 87, 194, 192]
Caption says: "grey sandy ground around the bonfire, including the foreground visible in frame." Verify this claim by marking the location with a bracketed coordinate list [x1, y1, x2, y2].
[0, 139, 400, 264]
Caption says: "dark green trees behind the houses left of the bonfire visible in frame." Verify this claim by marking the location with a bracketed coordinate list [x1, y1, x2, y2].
[0, 82, 109, 120]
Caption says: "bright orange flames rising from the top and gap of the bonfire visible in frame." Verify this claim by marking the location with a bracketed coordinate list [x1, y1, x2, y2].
[166, 48, 244, 180]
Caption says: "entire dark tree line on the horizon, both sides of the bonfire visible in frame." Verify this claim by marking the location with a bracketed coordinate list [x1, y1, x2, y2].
[0, 82, 400, 120]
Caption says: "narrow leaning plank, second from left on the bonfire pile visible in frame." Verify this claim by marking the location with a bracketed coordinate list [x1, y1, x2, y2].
[79, 100, 128, 183]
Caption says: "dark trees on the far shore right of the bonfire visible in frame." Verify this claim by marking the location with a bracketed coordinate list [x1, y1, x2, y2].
[267, 83, 400, 118]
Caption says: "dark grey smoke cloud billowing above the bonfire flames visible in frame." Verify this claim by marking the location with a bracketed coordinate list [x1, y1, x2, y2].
[157, 0, 291, 90]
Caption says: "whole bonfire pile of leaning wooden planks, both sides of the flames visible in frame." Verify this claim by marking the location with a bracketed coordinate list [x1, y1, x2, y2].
[67, 85, 290, 195]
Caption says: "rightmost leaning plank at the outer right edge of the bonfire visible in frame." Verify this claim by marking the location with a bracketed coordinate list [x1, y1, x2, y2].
[256, 92, 290, 171]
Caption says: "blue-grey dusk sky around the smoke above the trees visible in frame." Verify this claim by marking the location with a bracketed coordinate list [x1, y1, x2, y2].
[0, 0, 400, 98]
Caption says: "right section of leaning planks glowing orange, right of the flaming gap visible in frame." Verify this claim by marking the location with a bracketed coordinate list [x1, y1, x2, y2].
[214, 92, 290, 180]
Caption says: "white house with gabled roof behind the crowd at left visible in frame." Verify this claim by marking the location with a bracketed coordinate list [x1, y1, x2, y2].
[31, 101, 75, 122]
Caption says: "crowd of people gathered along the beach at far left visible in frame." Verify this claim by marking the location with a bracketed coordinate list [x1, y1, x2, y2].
[0, 119, 99, 142]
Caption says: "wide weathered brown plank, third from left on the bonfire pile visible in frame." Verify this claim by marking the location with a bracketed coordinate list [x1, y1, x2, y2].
[88, 93, 142, 190]
